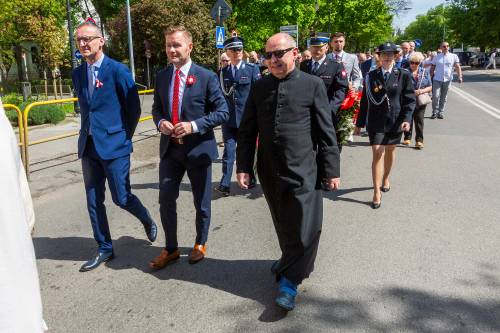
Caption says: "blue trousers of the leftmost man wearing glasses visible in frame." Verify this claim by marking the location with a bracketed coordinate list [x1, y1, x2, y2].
[82, 137, 152, 252]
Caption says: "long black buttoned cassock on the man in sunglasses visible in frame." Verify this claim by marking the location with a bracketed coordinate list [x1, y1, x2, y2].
[236, 69, 340, 284]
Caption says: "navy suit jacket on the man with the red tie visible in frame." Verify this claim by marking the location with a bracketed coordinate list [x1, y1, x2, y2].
[152, 63, 229, 165]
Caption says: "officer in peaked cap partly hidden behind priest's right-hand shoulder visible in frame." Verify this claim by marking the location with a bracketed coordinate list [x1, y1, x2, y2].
[300, 33, 349, 134]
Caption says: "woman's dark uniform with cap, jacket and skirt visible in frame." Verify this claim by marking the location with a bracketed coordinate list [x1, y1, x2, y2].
[356, 42, 416, 145]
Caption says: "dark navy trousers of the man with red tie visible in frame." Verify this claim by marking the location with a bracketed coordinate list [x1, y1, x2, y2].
[159, 143, 212, 249]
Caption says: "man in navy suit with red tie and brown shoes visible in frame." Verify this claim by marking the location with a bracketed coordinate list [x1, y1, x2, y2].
[149, 26, 229, 269]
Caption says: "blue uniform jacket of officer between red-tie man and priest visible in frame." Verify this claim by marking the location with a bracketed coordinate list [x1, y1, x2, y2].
[219, 62, 261, 128]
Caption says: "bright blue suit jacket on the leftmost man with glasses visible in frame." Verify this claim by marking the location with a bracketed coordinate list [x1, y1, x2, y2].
[72, 55, 141, 160]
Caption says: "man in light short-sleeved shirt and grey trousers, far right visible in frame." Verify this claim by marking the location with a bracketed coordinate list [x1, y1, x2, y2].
[431, 42, 463, 119]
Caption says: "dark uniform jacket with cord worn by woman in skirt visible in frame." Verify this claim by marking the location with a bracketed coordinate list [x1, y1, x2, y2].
[356, 66, 416, 133]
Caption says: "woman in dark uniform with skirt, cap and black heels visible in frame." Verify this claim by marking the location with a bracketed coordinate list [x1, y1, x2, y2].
[356, 42, 415, 209]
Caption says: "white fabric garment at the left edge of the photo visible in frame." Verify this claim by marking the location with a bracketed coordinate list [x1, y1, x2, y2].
[0, 100, 46, 333]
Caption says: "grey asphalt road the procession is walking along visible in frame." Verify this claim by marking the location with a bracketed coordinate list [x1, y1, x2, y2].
[32, 68, 500, 332]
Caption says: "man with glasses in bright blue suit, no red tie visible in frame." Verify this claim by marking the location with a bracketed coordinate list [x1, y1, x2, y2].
[73, 21, 157, 272]
